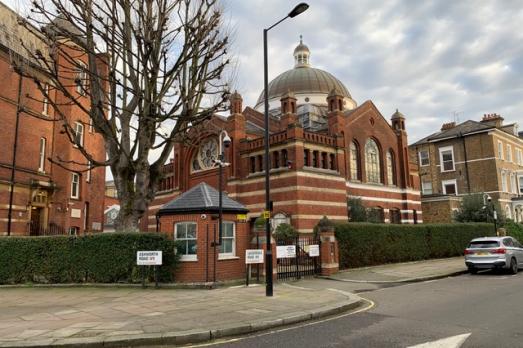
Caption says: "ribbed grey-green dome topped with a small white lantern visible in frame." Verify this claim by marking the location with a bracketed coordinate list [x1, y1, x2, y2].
[256, 38, 352, 105]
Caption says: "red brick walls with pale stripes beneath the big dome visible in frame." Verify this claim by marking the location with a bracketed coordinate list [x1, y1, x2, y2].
[147, 95, 423, 233]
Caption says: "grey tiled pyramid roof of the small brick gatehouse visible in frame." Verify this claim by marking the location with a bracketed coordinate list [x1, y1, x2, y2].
[158, 182, 249, 215]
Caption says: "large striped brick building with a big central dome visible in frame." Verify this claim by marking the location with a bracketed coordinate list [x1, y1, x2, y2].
[145, 41, 422, 242]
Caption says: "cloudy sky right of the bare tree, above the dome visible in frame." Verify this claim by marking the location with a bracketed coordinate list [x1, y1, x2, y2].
[224, 0, 523, 142]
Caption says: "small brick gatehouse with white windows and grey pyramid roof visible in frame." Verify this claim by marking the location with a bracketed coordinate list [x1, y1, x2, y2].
[157, 182, 250, 283]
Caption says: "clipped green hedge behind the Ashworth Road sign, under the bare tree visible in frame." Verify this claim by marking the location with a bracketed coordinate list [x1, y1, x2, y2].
[0, 233, 178, 284]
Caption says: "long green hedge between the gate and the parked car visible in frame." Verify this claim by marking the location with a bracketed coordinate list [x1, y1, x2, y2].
[336, 222, 494, 268]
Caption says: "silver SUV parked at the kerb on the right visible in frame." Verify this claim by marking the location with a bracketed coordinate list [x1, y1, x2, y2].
[465, 236, 523, 274]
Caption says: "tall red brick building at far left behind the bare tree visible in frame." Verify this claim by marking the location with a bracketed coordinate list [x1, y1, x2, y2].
[0, 3, 105, 235]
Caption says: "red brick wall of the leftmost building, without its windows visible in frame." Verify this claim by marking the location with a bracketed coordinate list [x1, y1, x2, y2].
[0, 40, 105, 235]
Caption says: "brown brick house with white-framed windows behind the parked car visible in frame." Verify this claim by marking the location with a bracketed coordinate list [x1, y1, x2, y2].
[409, 114, 523, 222]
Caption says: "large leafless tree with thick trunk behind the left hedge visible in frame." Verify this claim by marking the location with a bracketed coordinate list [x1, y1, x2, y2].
[17, 0, 228, 231]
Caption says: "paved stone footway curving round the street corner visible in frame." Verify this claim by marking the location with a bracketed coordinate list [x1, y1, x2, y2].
[0, 258, 465, 347]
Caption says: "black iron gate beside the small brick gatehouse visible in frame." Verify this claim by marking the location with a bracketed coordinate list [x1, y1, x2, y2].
[276, 237, 321, 279]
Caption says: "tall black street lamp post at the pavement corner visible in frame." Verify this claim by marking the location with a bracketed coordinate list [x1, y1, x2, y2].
[263, 2, 309, 296]
